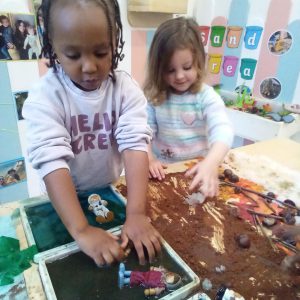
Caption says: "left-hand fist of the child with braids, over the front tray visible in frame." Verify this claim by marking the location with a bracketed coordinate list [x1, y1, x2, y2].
[76, 225, 124, 266]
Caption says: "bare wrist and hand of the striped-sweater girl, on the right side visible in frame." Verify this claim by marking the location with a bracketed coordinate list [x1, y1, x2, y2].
[186, 142, 229, 197]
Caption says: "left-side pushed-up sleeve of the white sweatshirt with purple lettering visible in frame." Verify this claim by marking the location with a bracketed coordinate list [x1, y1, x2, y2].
[22, 73, 74, 177]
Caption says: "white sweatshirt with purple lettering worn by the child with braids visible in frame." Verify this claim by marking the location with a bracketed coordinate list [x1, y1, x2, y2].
[22, 68, 151, 191]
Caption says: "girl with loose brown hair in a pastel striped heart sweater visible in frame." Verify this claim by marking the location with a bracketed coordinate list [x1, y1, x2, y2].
[144, 18, 233, 197]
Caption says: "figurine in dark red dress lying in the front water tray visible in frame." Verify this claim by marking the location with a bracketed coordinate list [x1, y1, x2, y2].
[119, 263, 181, 296]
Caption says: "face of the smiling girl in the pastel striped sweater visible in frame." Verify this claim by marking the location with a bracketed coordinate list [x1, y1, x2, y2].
[164, 49, 197, 94]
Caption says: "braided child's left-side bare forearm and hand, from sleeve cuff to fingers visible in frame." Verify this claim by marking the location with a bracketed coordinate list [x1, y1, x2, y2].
[44, 169, 124, 266]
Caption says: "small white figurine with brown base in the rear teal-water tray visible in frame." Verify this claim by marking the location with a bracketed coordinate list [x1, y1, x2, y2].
[88, 194, 114, 223]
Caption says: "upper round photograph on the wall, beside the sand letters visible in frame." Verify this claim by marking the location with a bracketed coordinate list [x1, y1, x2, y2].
[268, 30, 292, 55]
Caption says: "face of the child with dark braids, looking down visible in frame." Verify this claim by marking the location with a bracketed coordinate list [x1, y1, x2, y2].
[51, 3, 112, 91]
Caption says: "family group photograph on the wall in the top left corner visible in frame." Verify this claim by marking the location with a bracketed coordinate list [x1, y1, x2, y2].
[0, 12, 41, 60]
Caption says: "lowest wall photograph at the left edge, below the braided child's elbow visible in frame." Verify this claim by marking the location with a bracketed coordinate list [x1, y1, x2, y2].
[0, 157, 26, 188]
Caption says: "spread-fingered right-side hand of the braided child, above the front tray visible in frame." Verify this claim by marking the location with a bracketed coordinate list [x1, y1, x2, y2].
[121, 214, 161, 265]
